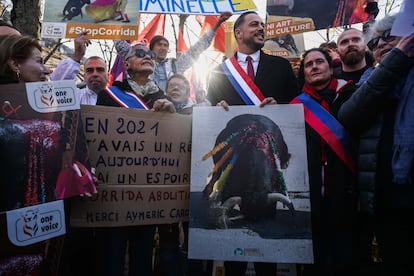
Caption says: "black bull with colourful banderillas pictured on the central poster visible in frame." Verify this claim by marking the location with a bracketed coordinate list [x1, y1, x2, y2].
[203, 114, 294, 228]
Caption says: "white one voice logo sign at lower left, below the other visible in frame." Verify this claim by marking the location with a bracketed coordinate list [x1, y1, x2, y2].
[6, 200, 66, 246]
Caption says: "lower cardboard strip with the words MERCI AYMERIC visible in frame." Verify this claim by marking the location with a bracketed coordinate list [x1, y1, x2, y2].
[70, 185, 190, 227]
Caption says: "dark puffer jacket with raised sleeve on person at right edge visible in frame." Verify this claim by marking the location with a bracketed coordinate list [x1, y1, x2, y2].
[338, 49, 414, 215]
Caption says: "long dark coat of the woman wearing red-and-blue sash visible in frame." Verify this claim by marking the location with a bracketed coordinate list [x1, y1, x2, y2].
[293, 77, 356, 268]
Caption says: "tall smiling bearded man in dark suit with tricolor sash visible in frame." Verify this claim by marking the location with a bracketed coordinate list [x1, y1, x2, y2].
[207, 11, 299, 276]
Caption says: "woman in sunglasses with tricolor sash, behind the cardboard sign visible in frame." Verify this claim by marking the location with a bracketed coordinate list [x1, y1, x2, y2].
[96, 44, 175, 276]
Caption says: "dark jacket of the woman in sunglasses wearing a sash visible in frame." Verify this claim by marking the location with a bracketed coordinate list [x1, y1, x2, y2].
[96, 79, 169, 108]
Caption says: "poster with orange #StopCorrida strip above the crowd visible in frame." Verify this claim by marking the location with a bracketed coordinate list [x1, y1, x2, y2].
[41, 0, 140, 40]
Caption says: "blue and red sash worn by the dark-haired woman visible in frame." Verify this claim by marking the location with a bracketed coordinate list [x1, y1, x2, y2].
[291, 93, 356, 172]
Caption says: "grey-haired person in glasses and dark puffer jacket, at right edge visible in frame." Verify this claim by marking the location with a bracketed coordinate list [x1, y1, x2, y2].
[338, 16, 414, 275]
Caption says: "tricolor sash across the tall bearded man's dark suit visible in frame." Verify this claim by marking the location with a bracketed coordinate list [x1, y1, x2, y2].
[221, 56, 265, 105]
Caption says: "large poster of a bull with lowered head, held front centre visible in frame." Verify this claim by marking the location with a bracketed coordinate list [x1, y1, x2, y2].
[188, 105, 313, 263]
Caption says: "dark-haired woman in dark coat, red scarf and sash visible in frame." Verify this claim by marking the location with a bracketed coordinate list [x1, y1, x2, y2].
[291, 48, 355, 275]
